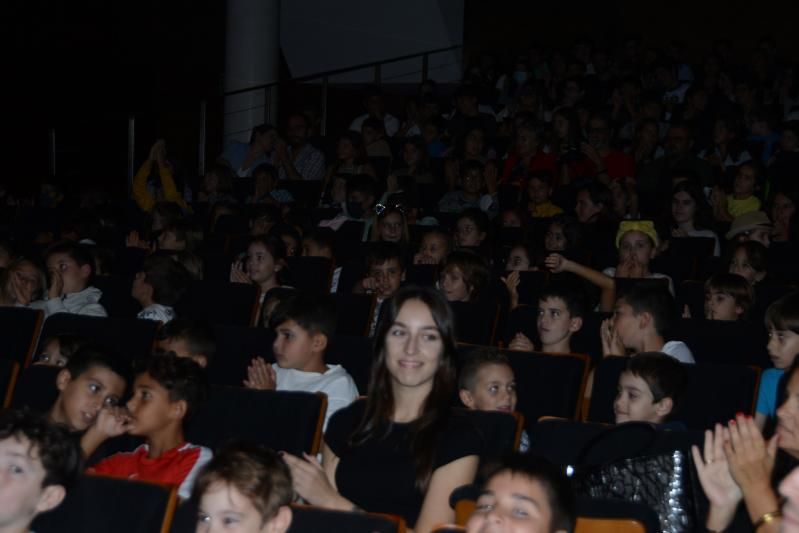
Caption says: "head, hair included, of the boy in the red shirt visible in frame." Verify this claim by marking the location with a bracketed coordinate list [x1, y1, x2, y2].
[127, 353, 208, 437]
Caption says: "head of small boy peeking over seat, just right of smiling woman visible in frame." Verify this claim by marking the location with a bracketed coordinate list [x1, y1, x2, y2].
[458, 349, 516, 413]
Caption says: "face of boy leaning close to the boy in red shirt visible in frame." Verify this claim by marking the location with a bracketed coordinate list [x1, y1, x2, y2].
[54, 365, 125, 431]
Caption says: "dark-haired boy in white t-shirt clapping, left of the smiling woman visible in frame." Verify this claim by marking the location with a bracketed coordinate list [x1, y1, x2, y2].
[244, 293, 358, 427]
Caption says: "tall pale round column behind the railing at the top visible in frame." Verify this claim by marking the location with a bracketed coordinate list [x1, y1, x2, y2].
[224, 0, 280, 142]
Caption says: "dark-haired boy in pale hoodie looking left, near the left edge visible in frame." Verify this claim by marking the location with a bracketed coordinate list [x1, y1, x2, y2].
[31, 241, 108, 316]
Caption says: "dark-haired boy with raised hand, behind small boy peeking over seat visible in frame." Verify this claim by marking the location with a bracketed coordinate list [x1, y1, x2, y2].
[508, 282, 588, 353]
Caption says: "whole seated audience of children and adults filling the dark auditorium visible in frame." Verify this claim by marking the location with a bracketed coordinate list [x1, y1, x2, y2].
[0, 35, 799, 533]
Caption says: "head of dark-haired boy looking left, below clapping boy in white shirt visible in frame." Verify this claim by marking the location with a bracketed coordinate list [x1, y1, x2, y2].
[613, 352, 688, 424]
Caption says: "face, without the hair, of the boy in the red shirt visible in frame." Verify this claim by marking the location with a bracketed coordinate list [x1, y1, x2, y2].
[127, 372, 185, 436]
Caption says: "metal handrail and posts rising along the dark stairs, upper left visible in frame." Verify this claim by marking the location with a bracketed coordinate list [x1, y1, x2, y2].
[48, 45, 463, 181]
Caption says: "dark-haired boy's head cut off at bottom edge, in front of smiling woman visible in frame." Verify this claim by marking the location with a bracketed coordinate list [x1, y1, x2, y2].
[466, 454, 577, 533]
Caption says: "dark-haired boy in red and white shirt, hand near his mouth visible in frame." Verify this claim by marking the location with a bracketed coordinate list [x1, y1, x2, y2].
[90, 354, 211, 499]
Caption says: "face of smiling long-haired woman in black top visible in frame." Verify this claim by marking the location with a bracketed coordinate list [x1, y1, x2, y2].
[384, 299, 444, 390]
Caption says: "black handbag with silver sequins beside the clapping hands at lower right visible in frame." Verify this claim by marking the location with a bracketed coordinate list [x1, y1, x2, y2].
[572, 423, 698, 533]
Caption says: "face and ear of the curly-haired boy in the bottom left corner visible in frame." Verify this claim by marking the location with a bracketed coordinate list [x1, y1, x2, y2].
[0, 435, 64, 531]
